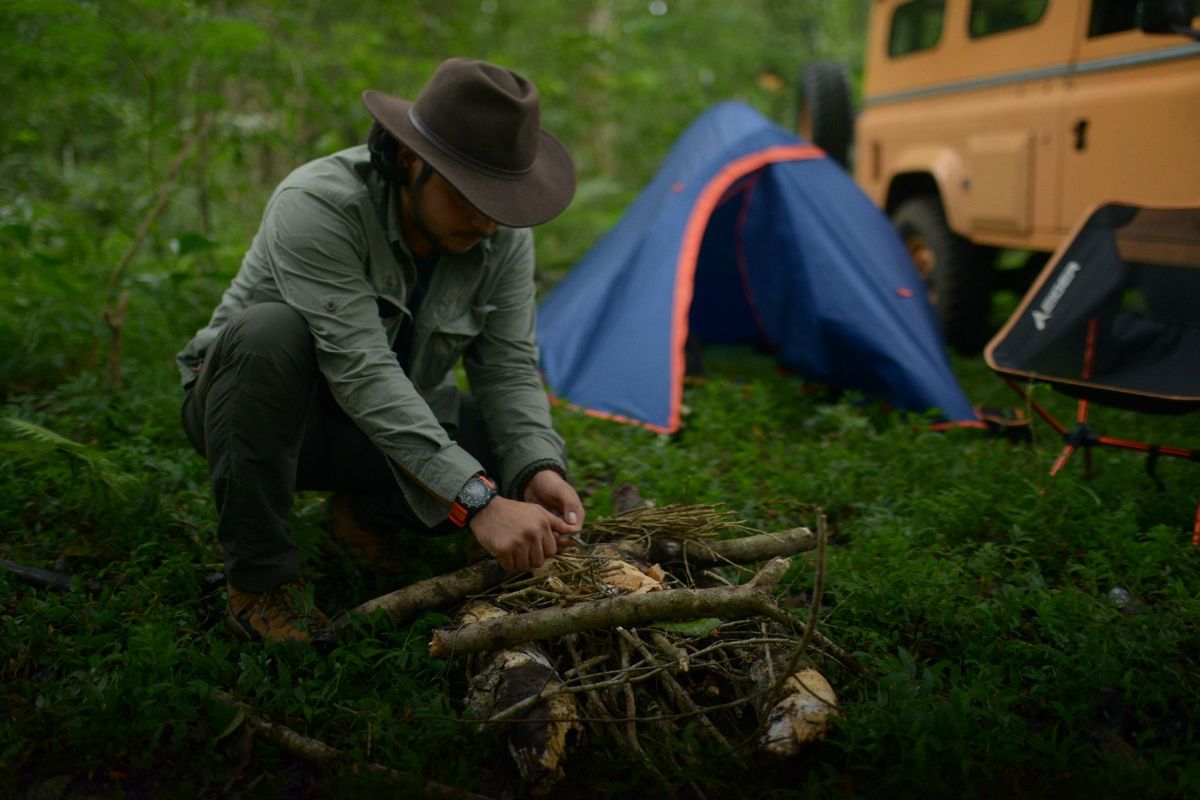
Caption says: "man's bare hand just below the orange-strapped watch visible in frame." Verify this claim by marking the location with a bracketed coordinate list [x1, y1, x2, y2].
[470, 496, 582, 572]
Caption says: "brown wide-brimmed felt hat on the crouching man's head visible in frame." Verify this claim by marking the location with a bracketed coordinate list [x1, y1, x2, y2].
[362, 59, 575, 228]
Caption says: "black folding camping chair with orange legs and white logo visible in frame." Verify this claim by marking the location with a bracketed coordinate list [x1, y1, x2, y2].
[984, 204, 1200, 547]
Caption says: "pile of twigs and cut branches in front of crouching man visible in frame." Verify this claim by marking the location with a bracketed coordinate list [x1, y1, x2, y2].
[446, 506, 848, 794]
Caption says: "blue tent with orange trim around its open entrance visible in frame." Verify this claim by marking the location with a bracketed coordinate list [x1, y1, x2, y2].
[538, 102, 974, 433]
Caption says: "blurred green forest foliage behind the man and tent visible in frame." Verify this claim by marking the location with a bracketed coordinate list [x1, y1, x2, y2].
[0, 0, 866, 390]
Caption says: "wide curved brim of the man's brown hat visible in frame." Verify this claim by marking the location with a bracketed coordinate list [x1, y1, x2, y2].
[362, 90, 575, 228]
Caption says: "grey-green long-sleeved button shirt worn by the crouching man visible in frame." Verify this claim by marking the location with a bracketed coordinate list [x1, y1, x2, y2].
[178, 146, 566, 525]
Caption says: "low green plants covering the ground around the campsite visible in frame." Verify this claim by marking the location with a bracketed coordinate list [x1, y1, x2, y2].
[0, 340, 1200, 798]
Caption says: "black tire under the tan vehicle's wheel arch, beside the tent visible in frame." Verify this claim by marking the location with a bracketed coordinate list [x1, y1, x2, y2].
[892, 194, 991, 355]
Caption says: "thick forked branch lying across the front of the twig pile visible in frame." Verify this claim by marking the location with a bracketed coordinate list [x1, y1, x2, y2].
[430, 559, 790, 658]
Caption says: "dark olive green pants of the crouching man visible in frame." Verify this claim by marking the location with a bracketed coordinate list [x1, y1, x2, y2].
[182, 303, 493, 593]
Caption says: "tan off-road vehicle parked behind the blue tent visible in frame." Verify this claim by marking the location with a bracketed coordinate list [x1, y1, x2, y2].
[799, 0, 1200, 351]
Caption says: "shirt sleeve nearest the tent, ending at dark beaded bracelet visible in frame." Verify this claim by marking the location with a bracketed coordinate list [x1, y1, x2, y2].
[463, 230, 566, 495]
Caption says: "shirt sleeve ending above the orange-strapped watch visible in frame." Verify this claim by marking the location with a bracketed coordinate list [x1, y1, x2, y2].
[263, 188, 482, 525]
